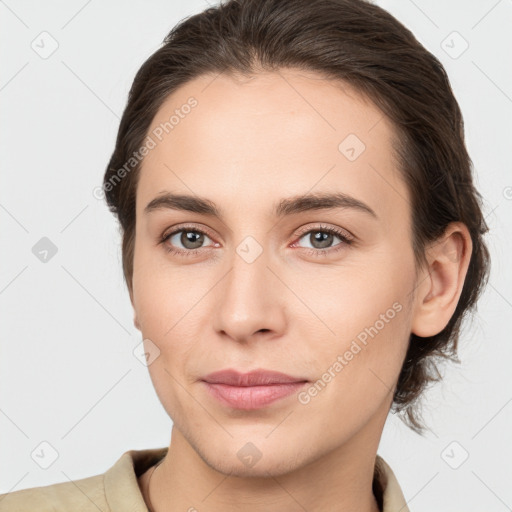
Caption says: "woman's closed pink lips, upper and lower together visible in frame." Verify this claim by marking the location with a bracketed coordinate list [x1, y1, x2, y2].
[202, 369, 308, 410]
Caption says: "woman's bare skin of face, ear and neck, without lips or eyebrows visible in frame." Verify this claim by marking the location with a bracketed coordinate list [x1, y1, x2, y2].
[130, 69, 471, 512]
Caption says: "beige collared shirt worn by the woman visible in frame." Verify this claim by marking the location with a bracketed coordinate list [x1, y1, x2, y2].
[0, 447, 409, 512]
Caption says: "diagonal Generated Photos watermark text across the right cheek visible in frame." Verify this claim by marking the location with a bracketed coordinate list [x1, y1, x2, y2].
[297, 302, 403, 405]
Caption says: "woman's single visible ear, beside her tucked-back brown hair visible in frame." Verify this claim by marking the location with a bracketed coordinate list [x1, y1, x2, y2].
[411, 222, 473, 337]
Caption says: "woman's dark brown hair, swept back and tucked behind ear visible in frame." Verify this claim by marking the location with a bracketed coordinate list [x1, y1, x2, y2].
[103, 0, 490, 434]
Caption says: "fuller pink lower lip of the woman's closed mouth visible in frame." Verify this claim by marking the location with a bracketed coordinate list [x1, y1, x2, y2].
[203, 381, 307, 411]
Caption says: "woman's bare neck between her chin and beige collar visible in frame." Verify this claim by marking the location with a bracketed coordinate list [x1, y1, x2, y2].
[139, 427, 380, 512]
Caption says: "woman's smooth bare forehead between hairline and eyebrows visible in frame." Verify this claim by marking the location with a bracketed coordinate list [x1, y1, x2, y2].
[137, 69, 407, 221]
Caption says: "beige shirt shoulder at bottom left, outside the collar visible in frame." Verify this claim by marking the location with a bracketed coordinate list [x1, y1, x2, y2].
[0, 475, 110, 512]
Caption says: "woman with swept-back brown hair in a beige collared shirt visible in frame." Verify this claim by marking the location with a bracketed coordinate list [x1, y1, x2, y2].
[0, 0, 489, 512]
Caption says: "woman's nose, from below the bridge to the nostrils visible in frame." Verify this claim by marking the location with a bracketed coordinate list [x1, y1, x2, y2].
[214, 246, 289, 343]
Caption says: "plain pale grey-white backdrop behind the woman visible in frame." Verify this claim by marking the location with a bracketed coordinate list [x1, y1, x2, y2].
[0, 0, 512, 512]
